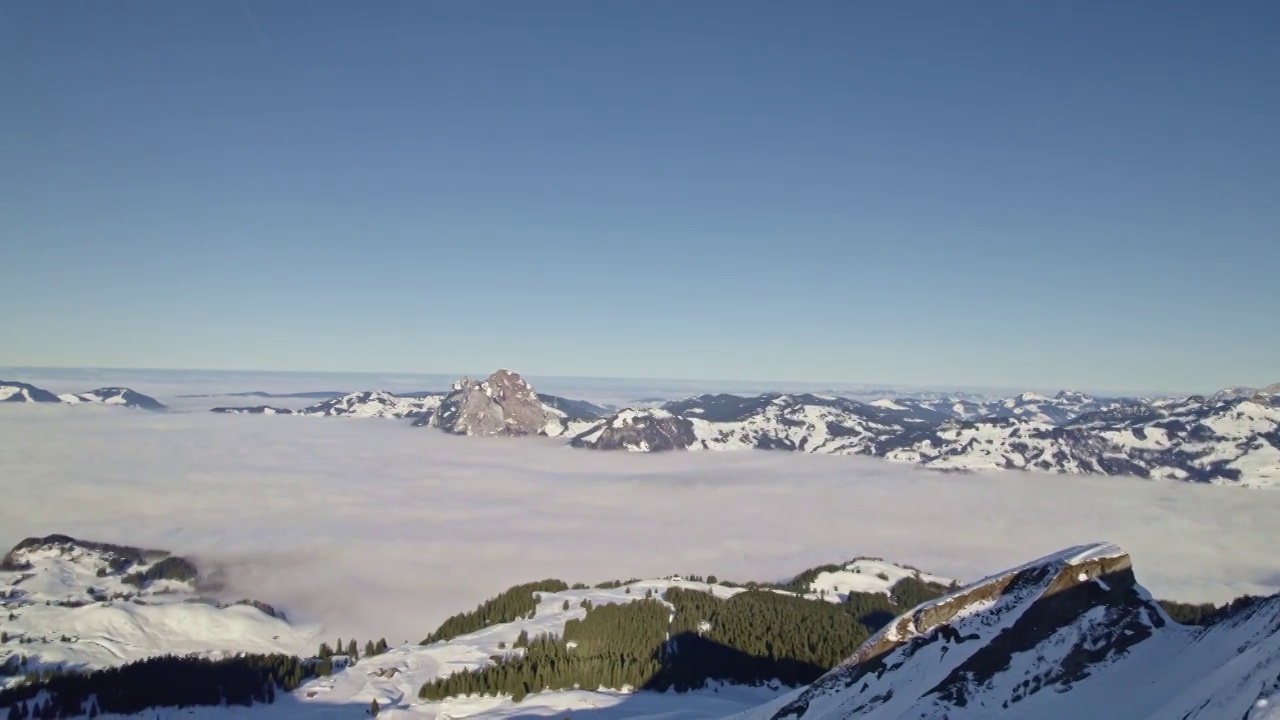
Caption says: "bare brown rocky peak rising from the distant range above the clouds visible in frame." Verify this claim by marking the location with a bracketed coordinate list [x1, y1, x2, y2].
[430, 370, 553, 436]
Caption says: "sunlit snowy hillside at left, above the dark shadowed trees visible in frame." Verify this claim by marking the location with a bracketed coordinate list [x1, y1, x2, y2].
[0, 536, 316, 688]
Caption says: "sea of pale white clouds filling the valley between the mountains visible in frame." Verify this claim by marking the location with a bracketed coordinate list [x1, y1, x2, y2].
[0, 388, 1280, 642]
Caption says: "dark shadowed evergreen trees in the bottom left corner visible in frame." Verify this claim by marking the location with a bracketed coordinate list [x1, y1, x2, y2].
[0, 655, 315, 720]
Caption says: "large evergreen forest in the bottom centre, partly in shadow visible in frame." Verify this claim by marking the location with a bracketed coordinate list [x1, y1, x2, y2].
[419, 578, 946, 702]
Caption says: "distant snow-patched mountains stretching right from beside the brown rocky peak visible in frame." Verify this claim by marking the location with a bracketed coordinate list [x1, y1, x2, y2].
[571, 391, 1280, 487]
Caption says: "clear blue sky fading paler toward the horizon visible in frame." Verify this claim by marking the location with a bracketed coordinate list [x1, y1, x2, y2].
[0, 0, 1280, 389]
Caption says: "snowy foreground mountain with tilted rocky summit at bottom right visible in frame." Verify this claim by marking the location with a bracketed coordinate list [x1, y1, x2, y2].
[736, 543, 1280, 720]
